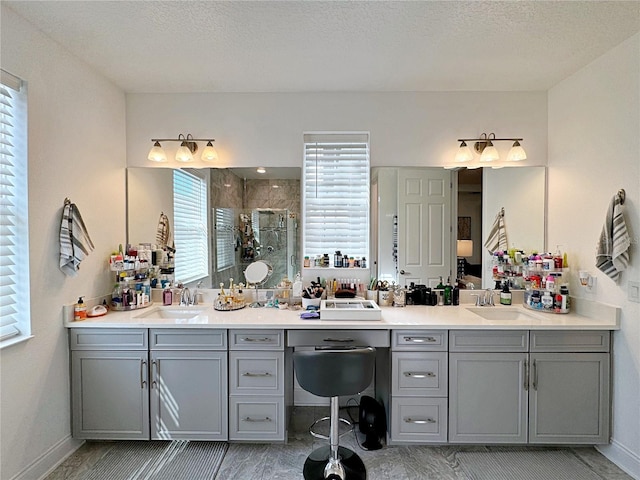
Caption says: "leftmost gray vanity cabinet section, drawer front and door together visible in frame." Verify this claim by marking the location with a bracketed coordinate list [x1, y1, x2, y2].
[70, 328, 149, 440]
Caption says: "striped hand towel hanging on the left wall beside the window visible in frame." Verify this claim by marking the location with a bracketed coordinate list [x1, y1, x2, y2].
[60, 202, 94, 277]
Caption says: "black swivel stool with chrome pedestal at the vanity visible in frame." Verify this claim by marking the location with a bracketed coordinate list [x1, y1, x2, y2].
[293, 347, 376, 480]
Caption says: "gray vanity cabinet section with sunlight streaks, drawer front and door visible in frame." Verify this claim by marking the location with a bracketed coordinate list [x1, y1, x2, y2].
[149, 328, 228, 440]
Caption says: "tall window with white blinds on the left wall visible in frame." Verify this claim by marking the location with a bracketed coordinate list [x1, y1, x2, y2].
[0, 70, 31, 347]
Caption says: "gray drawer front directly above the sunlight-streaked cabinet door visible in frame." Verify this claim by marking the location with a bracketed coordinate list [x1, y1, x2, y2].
[149, 328, 227, 350]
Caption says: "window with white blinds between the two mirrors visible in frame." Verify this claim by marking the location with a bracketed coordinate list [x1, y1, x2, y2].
[303, 133, 369, 257]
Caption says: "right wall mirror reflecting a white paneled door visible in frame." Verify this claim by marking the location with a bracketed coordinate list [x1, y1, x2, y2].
[371, 167, 547, 288]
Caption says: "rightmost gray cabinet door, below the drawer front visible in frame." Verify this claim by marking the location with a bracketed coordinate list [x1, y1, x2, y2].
[529, 353, 609, 445]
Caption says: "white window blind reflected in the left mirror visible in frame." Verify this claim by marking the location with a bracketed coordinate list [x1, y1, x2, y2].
[173, 170, 209, 283]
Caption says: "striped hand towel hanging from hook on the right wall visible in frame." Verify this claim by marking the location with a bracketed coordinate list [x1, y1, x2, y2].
[596, 195, 631, 282]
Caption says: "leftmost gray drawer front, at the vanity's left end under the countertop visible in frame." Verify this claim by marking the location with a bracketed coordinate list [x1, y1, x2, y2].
[69, 328, 148, 350]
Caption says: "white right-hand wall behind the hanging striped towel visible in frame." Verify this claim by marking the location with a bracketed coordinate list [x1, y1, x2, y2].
[548, 34, 640, 478]
